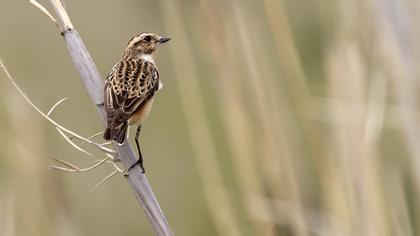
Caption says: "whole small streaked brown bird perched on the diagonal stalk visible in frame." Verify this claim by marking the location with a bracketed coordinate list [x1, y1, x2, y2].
[103, 33, 171, 173]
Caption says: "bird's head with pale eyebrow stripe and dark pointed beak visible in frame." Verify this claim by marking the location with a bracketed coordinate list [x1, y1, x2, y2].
[123, 33, 171, 62]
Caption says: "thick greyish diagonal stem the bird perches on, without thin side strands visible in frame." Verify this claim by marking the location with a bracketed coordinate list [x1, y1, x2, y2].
[47, 0, 173, 236]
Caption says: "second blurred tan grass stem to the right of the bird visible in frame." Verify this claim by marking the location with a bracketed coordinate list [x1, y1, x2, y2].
[201, 1, 274, 235]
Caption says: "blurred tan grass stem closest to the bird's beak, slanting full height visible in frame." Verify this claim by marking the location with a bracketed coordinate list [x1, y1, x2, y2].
[160, 0, 241, 235]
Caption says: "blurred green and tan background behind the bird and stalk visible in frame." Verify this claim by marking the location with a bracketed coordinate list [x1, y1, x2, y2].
[0, 0, 420, 236]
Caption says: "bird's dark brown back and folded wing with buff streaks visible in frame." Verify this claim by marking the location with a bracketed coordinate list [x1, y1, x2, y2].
[105, 59, 159, 128]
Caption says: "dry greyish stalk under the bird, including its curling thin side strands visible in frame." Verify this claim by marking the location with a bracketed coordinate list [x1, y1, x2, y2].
[0, 0, 173, 236]
